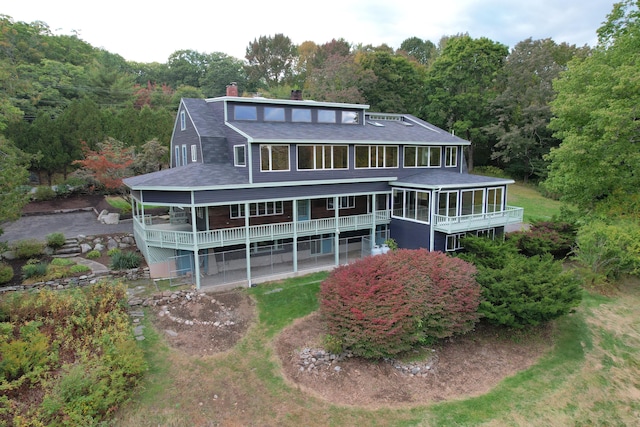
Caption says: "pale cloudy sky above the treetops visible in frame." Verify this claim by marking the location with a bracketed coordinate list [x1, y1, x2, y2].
[0, 0, 614, 62]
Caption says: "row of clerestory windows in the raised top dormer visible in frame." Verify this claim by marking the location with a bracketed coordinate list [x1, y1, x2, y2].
[233, 105, 359, 124]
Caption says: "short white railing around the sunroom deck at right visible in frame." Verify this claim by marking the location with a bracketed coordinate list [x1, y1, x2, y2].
[433, 206, 524, 234]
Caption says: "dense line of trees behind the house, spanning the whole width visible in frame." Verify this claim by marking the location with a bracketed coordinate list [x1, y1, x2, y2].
[0, 0, 639, 217]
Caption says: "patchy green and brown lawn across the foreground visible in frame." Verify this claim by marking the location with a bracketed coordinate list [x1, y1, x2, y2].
[114, 273, 640, 427]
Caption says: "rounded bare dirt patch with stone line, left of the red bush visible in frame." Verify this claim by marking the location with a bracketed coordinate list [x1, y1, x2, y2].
[153, 291, 255, 356]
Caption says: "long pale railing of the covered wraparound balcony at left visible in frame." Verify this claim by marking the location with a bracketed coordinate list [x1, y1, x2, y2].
[133, 211, 390, 250]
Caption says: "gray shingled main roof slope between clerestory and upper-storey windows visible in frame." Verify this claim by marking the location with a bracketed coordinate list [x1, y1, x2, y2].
[230, 115, 469, 145]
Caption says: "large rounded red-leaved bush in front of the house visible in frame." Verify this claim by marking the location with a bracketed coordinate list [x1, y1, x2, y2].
[320, 249, 480, 358]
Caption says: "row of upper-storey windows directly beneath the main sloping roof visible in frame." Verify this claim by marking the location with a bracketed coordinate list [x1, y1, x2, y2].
[252, 144, 458, 172]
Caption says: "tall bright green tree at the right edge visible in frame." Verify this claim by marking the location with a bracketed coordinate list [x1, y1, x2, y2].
[545, 0, 640, 209]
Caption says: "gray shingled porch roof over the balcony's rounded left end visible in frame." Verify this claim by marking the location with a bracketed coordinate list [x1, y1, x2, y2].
[123, 163, 249, 189]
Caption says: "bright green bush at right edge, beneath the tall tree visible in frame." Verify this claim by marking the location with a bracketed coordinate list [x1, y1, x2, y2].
[573, 220, 640, 285]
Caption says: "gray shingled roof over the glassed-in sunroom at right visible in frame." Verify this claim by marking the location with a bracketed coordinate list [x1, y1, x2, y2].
[390, 169, 514, 188]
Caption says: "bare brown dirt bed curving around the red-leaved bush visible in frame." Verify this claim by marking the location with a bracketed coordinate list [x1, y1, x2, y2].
[274, 314, 552, 408]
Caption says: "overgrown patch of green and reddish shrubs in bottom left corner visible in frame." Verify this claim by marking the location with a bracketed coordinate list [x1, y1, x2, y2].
[0, 282, 146, 426]
